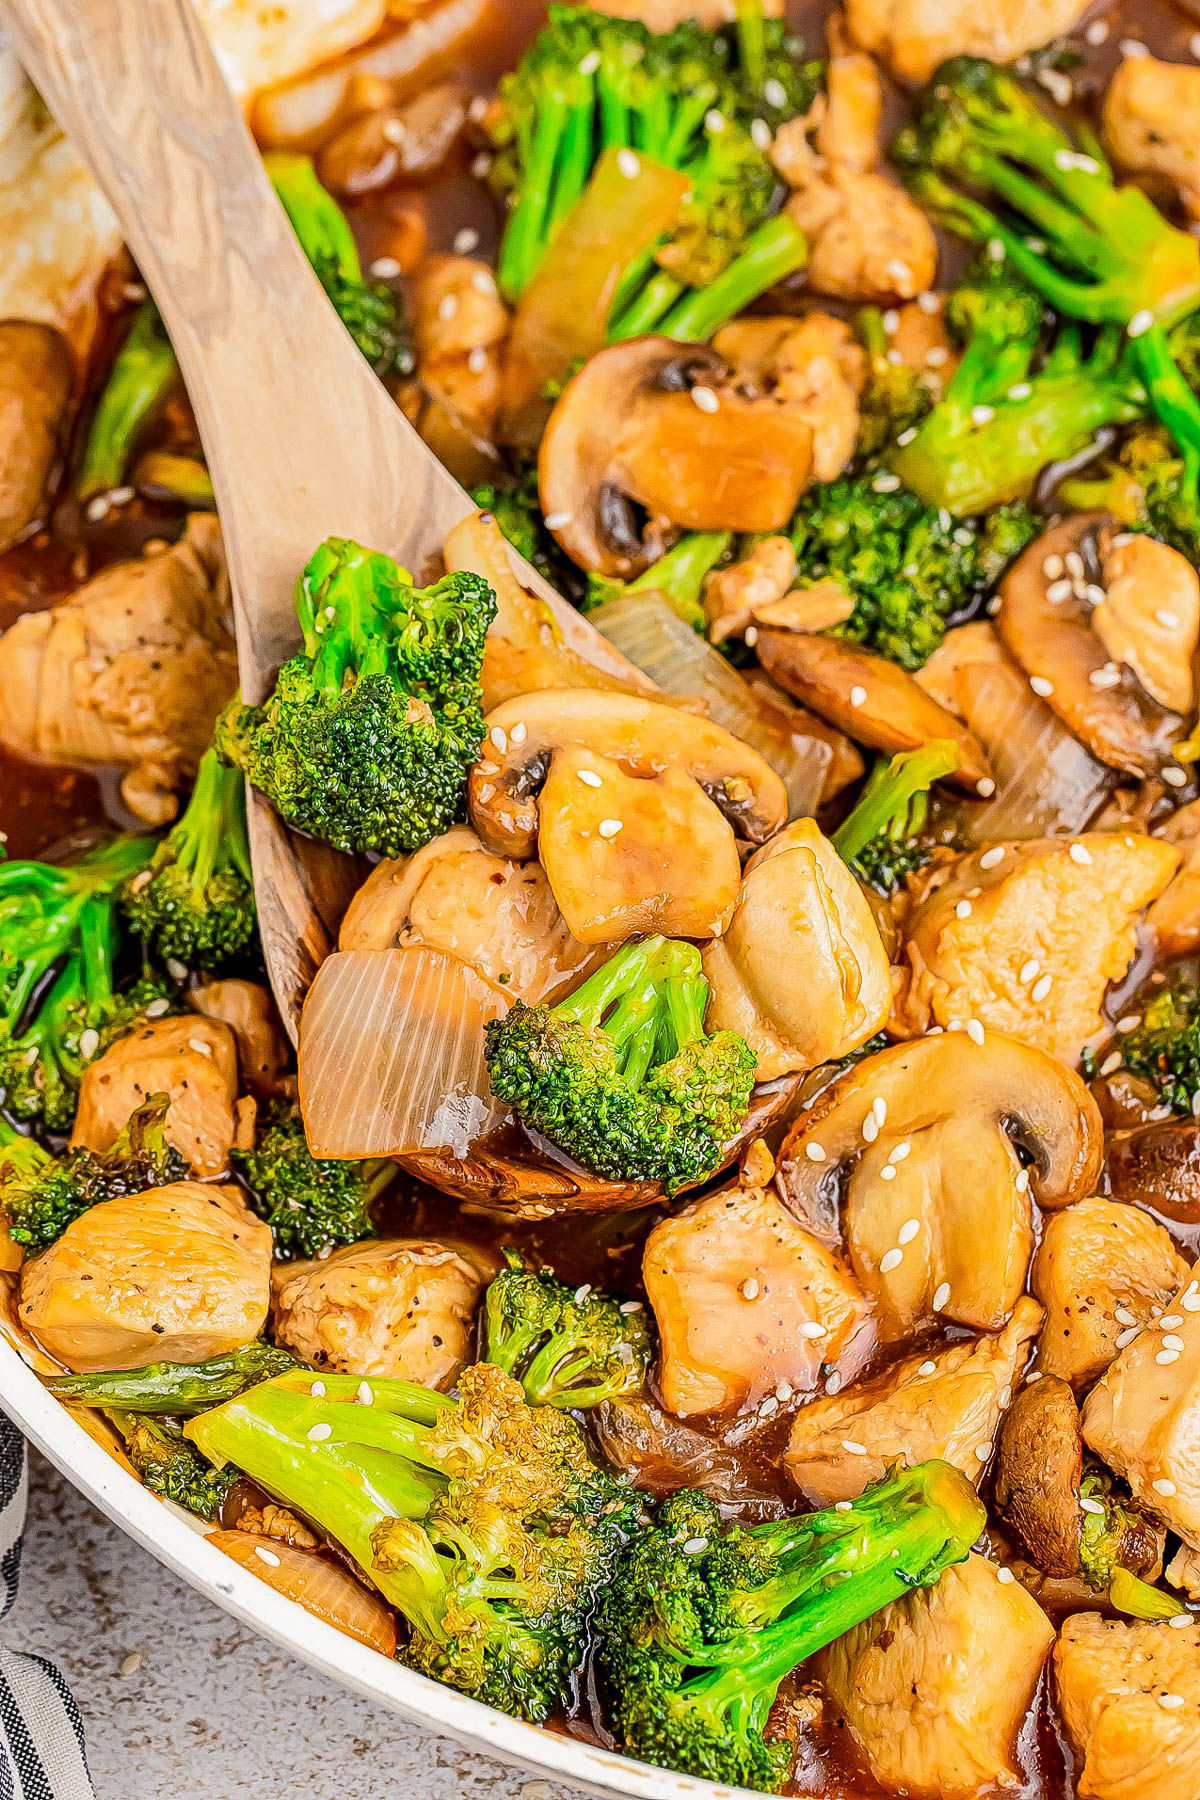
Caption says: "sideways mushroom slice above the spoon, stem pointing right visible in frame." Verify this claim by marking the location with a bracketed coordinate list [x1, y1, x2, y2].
[538, 337, 813, 580]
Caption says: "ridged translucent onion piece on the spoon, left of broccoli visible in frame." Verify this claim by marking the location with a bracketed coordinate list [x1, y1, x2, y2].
[299, 945, 509, 1159]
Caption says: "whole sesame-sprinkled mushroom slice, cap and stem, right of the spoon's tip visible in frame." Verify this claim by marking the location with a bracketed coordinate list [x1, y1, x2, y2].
[779, 1031, 1103, 1337]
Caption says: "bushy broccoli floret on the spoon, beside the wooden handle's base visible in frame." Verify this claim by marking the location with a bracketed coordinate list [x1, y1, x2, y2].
[214, 538, 497, 857]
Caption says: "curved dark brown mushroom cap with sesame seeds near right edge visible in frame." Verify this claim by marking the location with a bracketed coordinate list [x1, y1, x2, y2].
[997, 513, 1184, 778]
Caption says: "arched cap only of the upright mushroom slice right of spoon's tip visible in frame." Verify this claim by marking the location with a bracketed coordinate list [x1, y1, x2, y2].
[779, 1031, 1105, 1237]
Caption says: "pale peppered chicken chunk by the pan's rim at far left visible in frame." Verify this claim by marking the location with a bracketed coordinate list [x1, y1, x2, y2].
[16, 1181, 272, 1373]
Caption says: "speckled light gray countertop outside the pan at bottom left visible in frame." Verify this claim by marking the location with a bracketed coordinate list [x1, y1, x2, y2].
[4, 1456, 586, 1800]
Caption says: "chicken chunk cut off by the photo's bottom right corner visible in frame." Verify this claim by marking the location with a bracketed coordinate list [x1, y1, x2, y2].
[1054, 1613, 1200, 1800]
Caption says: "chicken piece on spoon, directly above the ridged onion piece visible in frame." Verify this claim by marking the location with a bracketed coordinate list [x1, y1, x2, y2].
[338, 824, 594, 1006]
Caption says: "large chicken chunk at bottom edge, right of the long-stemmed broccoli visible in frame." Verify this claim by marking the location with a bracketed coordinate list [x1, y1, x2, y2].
[820, 1555, 1054, 1796]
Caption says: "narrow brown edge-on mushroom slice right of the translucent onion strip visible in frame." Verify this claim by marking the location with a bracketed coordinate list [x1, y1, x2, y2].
[756, 628, 991, 794]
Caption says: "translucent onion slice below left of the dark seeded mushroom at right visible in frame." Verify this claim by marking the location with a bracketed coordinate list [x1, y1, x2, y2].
[955, 662, 1114, 844]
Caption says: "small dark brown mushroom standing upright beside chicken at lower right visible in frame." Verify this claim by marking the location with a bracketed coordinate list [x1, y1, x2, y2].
[995, 1375, 1083, 1577]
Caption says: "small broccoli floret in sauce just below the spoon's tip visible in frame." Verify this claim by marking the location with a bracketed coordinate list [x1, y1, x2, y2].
[482, 1251, 649, 1409]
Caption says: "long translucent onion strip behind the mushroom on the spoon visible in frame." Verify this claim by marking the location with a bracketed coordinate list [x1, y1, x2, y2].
[588, 590, 833, 819]
